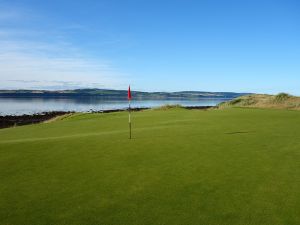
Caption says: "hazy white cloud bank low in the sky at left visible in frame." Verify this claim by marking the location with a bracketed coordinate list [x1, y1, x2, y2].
[0, 40, 122, 88]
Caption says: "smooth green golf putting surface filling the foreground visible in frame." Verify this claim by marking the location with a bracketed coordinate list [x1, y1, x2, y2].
[0, 108, 300, 225]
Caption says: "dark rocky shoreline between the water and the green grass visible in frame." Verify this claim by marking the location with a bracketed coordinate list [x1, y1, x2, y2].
[0, 106, 216, 129]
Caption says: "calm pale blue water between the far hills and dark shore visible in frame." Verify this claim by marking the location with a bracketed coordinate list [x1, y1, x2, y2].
[0, 98, 228, 115]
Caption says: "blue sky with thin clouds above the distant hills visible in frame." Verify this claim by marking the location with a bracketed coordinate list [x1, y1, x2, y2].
[0, 0, 300, 95]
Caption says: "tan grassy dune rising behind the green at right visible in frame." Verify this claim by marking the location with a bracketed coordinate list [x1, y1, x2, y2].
[219, 93, 300, 110]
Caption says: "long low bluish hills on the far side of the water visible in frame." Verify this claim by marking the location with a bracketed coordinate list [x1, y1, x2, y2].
[0, 89, 247, 99]
